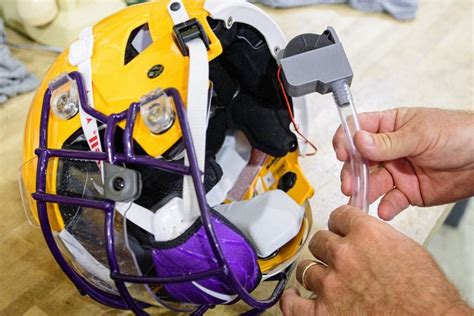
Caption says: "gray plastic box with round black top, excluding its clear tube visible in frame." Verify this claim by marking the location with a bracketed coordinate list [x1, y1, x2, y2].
[279, 26, 353, 97]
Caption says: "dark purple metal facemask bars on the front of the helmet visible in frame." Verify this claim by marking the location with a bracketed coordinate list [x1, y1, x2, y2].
[32, 72, 292, 315]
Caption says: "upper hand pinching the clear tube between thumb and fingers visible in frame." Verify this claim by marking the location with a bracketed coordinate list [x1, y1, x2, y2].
[333, 108, 474, 220]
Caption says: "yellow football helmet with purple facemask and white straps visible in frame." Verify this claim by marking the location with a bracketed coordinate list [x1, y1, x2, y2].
[20, 0, 314, 314]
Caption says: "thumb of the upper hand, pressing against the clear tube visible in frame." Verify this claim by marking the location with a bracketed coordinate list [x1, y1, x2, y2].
[354, 130, 418, 161]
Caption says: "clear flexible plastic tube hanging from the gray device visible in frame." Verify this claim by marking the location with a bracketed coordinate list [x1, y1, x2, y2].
[333, 82, 369, 213]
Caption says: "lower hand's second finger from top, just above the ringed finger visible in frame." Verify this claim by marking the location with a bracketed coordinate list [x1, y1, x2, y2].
[308, 230, 342, 265]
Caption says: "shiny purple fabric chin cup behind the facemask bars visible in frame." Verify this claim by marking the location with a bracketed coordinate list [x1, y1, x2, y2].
[153, 215, 261, 305]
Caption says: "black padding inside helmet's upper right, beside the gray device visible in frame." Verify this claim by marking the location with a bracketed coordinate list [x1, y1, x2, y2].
[207, 19, 297, 157]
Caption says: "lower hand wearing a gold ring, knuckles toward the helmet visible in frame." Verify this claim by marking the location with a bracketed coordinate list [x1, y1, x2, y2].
[280, 205, 472, 316]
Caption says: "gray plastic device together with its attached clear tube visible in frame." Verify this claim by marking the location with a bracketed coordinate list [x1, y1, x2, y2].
[278, 27, 369, 212]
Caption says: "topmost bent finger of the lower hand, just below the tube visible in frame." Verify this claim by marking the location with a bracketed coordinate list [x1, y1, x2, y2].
[328, 205, 369, 236]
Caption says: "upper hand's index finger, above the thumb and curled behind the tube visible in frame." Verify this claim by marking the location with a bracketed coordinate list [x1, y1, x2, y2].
[332, 110, 397, 161]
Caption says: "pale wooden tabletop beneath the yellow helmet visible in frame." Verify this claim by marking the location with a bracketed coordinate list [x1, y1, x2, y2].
[0, 0, 474, 315]
